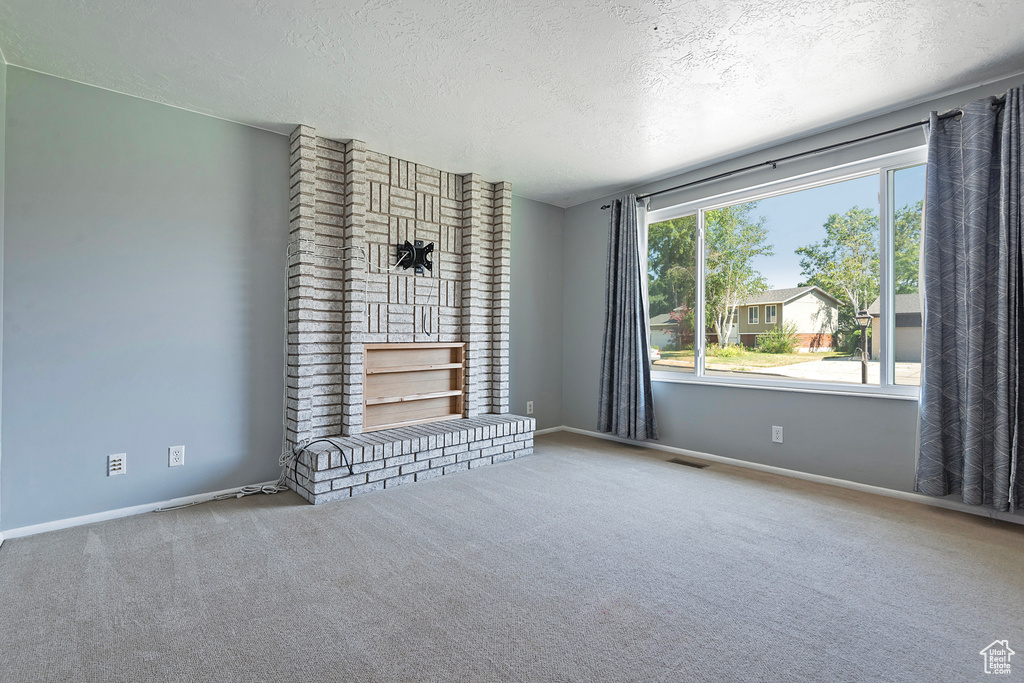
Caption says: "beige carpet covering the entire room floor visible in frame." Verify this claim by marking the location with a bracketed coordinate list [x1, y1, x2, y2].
[0, 433, 1024, 682]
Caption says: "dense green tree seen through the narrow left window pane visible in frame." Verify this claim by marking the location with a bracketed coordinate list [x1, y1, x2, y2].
[647, 216, 697, 317]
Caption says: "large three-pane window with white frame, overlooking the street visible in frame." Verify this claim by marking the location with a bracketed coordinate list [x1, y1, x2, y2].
[647, 150, 925, 395]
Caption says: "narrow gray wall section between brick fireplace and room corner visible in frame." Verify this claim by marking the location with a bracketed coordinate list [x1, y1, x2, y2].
[510, 195, 565, 429]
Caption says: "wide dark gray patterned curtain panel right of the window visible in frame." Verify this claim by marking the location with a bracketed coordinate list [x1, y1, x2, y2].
[916, 88, 1024, 511]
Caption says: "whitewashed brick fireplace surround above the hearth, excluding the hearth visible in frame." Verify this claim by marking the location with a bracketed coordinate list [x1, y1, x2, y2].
[287, 126, 512, 448]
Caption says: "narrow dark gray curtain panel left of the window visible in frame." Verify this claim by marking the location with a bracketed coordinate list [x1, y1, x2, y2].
[597, 195, 657, 441]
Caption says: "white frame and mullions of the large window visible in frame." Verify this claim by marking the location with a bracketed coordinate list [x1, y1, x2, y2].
[640, 145, 928, 400]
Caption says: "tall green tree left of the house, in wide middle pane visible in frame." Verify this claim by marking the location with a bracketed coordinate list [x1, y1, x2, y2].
[705, 202, 774, 348]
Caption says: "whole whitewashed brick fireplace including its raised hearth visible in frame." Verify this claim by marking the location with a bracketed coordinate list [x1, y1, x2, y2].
[286, 126, 535, 503]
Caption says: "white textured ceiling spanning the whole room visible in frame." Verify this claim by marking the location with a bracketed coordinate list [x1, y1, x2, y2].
[0, 0, 1024, 206]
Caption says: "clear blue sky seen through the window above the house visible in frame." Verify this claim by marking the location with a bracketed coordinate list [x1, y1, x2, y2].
[752, 165, 925, 289]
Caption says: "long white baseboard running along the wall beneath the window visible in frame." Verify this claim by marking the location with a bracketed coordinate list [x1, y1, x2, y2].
[535, 425, 1024, 524]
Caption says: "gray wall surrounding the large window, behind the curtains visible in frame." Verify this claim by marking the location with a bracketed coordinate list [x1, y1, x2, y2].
[562, 72, 1022, 490]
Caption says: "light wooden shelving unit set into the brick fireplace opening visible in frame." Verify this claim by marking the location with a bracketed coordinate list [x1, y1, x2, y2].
[362, 342, 466, 432]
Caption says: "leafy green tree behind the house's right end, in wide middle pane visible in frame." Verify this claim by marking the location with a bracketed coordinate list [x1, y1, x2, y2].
[797, 206, 879, 319]
